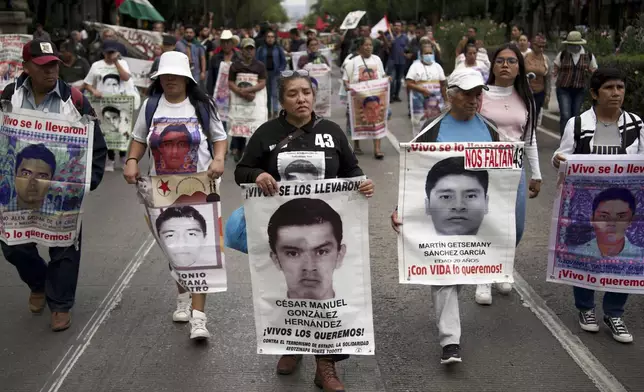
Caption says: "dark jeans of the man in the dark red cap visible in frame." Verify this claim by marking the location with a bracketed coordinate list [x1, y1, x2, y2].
[0, 232, 81, 312]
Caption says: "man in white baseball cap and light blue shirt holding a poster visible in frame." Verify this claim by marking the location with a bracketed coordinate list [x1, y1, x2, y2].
[391, 68, 499, 365]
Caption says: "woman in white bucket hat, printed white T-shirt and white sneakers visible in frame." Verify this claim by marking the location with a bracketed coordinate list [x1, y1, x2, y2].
[123, 51, 227, 339]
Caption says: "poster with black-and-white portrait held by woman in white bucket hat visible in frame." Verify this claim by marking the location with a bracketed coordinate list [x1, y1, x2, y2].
[137, 172, 226, 293]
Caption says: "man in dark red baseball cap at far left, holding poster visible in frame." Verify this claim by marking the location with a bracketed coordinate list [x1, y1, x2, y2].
[0, 40, 107, 331]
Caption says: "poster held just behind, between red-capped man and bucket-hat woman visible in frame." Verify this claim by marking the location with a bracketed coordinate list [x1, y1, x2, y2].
[90, 95, 135, 151]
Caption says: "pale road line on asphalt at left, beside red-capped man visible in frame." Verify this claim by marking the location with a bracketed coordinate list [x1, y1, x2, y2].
[40, 234, 155, 392]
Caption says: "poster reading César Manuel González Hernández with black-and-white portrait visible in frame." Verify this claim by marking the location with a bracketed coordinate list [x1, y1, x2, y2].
[247, 178, 375, 355]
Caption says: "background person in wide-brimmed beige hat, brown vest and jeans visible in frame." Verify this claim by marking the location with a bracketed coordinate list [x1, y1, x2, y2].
[553, 31, 597, 135]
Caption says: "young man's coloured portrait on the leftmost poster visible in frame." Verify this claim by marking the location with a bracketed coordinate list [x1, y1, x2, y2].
[9, 144, 56, 211]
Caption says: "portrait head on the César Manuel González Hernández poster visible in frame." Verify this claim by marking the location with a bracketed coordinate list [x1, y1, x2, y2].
[267, 198, 347, 300]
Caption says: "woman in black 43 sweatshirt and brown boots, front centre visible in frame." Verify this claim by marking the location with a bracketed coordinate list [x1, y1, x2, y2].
[235, 70, 374, 391]
